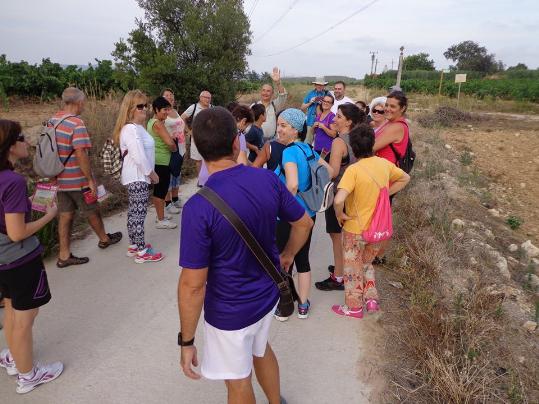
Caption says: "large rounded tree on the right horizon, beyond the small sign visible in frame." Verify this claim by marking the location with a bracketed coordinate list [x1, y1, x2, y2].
[444, 41, 503, 73]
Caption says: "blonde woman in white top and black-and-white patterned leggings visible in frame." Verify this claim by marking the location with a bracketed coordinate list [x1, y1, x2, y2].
[113, 90, 163, 264]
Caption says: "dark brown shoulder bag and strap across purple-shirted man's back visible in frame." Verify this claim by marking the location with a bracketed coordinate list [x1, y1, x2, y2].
[198, 187, 298, 317]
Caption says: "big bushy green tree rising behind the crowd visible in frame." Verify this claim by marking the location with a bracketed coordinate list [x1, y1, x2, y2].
[112, 0, 251, 107]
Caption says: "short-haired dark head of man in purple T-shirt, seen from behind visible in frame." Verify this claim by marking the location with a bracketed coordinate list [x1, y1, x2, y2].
[193, 107, 239, 161]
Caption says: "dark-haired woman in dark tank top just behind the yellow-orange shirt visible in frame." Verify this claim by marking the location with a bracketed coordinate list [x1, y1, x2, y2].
[315, 104, 366, 290]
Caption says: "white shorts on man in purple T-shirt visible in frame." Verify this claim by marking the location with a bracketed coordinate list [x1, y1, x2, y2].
[204, 308, 275, 380]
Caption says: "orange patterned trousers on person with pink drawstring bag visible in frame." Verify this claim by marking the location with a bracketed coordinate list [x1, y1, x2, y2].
[342, 230, 386, 309]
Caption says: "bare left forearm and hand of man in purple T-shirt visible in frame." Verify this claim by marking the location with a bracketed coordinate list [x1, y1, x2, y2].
[178, 268, 208, 379]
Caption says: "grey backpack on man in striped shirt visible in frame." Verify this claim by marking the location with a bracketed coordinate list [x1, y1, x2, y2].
[34, 115, 75, 178]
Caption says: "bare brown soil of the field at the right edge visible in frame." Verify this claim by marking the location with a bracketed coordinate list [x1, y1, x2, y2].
[443, 113, 539, 244]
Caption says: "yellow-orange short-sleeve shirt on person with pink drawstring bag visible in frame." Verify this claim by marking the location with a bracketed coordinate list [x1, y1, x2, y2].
[338, 156, 404, 234]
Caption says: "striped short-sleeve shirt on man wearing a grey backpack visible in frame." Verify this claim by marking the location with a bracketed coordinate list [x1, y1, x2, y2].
[51, 111, 92, 191]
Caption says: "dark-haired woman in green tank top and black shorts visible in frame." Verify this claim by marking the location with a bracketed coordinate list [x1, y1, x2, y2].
[147, 97, 178, 229]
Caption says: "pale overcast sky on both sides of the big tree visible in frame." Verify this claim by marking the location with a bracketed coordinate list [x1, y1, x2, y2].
[0, 0, 539, 77]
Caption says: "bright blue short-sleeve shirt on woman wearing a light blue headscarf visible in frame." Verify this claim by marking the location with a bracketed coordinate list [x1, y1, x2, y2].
[275, 142, 320, 218]
